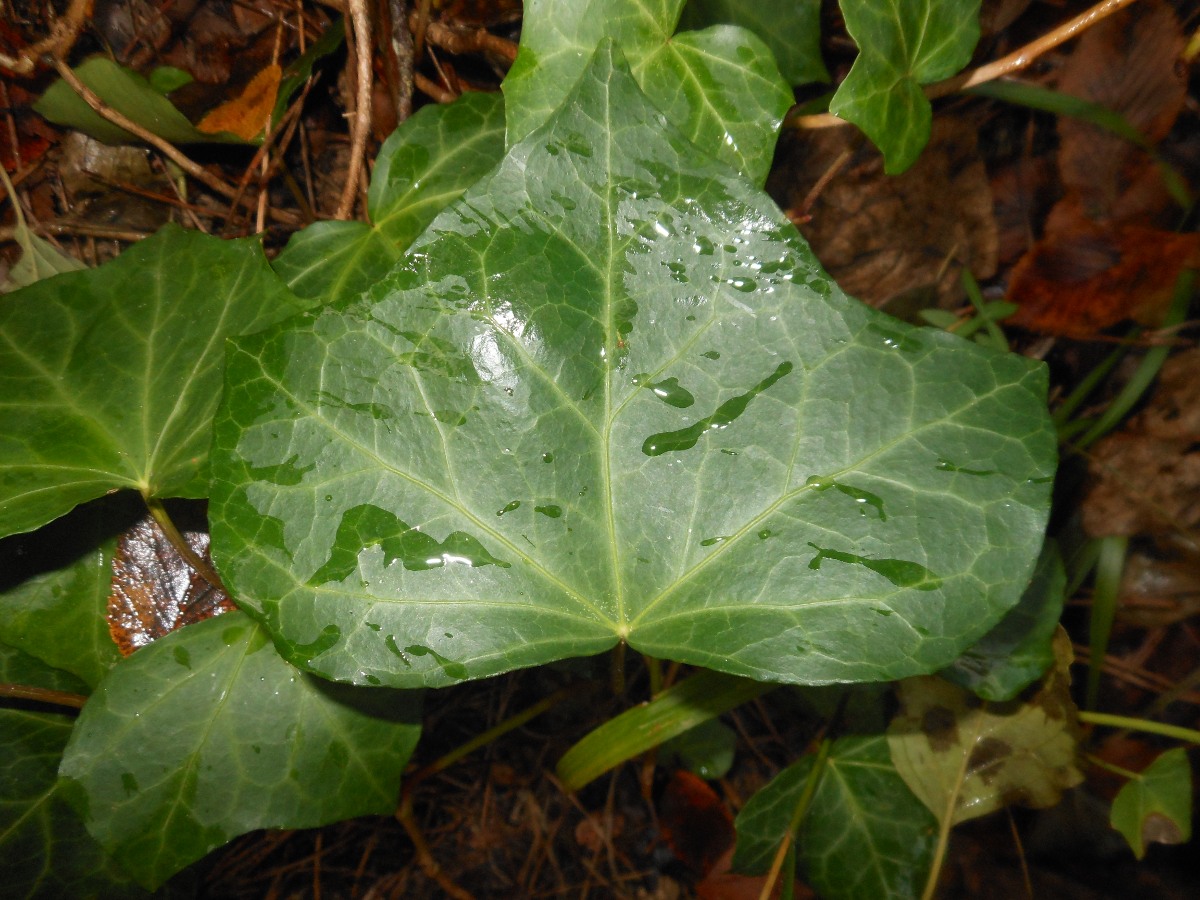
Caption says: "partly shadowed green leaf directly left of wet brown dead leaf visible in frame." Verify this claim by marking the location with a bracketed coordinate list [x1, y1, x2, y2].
[0, 498, 131, 688]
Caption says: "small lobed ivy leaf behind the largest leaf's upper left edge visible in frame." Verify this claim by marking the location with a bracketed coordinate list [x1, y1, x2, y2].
[272, 94, 504, 301]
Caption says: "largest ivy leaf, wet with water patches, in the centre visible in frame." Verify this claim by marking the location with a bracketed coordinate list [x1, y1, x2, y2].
[211, 46, 1055, 686]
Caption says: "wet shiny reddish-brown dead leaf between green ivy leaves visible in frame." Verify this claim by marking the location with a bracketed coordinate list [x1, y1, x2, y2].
[108, 515, 236, 656]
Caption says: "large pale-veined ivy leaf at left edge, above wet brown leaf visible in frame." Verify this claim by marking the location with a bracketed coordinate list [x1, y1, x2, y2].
[0, 226, 300, 535]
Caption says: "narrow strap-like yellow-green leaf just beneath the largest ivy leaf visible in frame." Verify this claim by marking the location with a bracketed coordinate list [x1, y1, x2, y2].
[556, 672, 773, 791]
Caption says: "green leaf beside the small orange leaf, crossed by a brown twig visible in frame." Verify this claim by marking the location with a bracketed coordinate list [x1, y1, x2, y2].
[34, 56, 246, 144]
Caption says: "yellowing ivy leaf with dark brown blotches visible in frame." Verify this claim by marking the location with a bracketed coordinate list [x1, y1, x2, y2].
[888, 629, 1084, 824]
